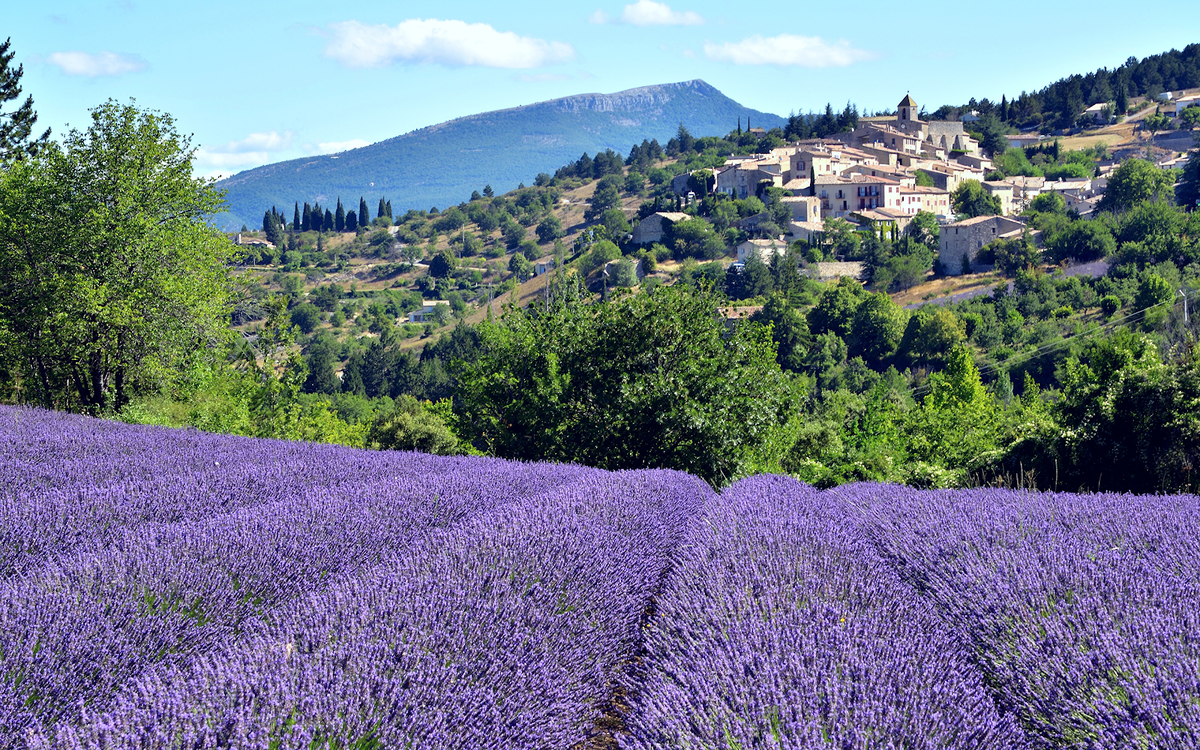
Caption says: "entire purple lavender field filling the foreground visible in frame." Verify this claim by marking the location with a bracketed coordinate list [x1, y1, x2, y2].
[0, 407, 1200, 750]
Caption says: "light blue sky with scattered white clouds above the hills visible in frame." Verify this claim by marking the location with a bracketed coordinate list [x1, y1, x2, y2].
[9, 0, 1200, 174]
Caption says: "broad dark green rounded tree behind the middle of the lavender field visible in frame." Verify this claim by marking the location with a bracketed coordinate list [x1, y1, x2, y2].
[455, 286, 796, 485]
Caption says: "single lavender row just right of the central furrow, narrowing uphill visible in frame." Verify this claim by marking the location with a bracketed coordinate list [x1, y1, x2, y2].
[622, 476, 1026, 750]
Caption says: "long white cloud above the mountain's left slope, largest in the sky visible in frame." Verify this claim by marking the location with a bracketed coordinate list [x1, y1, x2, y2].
[325, 18, 575, 68]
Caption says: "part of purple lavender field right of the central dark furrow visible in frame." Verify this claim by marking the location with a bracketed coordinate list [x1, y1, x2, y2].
[622, 478, 1200, 750]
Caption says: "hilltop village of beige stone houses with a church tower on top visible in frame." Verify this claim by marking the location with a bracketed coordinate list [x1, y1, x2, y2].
[632, 95, 1112, 280]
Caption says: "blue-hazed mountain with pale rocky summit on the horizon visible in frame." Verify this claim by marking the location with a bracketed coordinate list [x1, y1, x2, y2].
[217, 79, 785, 228]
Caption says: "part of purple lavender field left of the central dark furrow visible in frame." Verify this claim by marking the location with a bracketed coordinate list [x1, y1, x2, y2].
[0, 409, 712, 748]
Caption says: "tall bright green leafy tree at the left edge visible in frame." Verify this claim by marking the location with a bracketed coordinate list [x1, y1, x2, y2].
[0, 100, 234, 414]
